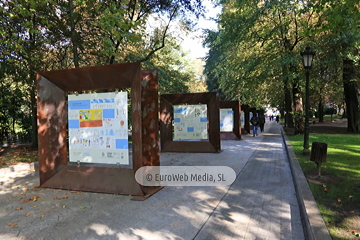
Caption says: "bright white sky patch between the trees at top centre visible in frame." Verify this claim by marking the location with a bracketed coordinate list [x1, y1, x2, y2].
[181, 0, 221, 59]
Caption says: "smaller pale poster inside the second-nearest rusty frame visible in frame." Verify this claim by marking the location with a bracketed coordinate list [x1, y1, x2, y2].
[174, 104, 208, 140]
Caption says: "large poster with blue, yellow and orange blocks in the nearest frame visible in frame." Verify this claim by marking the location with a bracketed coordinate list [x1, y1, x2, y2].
[68, 92, 130, 165]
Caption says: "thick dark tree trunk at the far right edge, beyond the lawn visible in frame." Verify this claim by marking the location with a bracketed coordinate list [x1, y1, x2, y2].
[343, 59, 359, 132]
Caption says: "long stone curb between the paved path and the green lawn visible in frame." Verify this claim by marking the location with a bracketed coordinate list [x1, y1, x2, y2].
[281, 128, 332, 240]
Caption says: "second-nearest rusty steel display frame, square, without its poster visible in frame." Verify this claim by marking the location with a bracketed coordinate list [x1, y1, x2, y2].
[160, 93, 221, 153]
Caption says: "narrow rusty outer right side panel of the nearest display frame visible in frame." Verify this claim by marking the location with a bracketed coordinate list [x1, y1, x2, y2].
[141, 70, 160, 166]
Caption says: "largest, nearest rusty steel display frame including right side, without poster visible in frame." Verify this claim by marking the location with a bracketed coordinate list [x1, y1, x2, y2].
[37, 63, 160, 196]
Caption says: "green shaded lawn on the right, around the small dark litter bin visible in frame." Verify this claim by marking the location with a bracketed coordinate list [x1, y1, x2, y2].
[289, 134, 360, 239]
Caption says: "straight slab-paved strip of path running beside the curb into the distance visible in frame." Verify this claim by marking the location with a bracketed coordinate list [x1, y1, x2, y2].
[195, 122, 304, 240]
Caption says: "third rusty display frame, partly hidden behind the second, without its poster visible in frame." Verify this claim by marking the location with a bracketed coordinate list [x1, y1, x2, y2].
[220, 101, 241, 140]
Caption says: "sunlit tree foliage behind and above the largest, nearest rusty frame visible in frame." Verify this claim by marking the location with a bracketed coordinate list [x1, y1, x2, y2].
[0, 0, 203, 142]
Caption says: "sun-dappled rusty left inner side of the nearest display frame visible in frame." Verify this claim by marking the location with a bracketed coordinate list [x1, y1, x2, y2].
[37, 75, 67, 185]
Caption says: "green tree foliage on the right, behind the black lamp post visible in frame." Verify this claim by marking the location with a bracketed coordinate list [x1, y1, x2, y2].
[205, 0, 360, 116]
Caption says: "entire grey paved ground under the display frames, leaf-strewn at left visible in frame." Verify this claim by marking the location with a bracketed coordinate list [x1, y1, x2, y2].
[0, 122, 310, 240]
